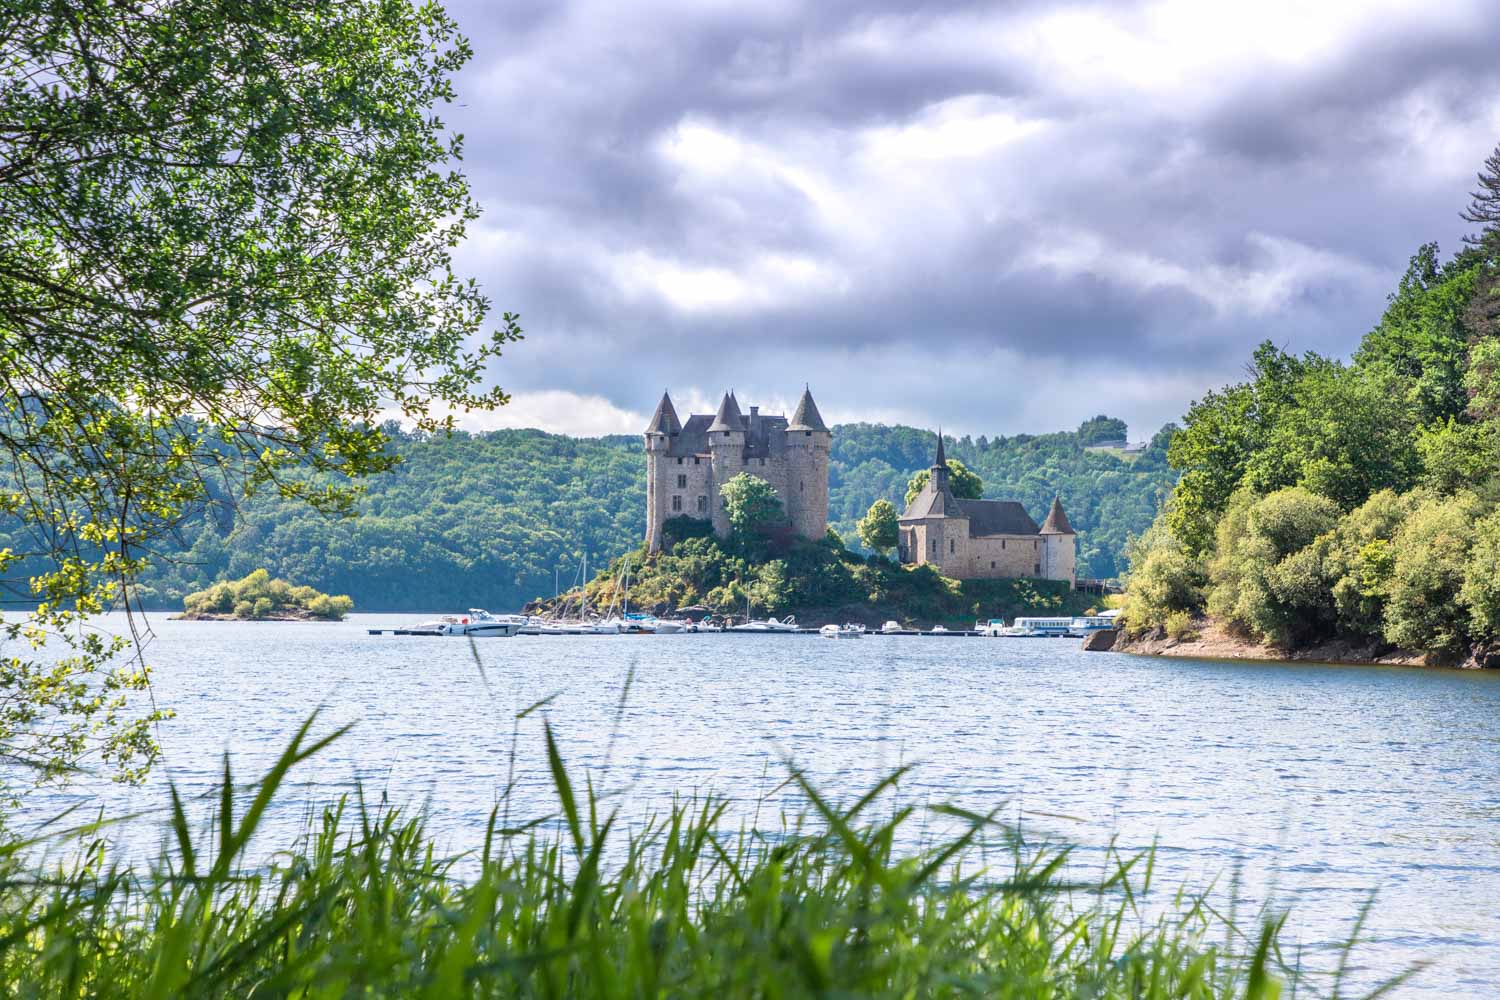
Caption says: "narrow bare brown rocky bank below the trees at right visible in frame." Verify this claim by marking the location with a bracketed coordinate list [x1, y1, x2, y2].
[1085, 619, 1500, 669]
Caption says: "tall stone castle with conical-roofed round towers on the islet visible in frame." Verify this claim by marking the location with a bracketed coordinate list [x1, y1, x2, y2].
[645, 390, 833, 552]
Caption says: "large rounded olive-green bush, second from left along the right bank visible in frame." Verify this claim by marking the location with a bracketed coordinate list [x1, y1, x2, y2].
[1208, 486, 1338, 646]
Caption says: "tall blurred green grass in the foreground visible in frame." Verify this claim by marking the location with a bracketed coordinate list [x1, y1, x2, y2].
[0, 720, 1404, 1000]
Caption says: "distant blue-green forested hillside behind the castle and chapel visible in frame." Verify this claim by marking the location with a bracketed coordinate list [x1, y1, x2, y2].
[111, 420, 1173, 610]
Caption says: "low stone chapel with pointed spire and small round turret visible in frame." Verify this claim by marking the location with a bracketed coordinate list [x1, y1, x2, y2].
[897, 432, 1077, 586]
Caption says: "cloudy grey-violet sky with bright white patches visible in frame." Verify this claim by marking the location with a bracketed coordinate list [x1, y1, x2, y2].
[441, 0, 1500, 439]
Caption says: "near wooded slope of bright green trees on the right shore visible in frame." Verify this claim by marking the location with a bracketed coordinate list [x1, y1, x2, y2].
[1127, 134, 1500, 666]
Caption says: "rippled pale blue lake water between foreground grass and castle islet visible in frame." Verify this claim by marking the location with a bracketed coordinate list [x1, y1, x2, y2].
[11, 615, 1500, 997]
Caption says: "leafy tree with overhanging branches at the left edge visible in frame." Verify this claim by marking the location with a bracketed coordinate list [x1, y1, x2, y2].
[0, 0, 521, 778]
